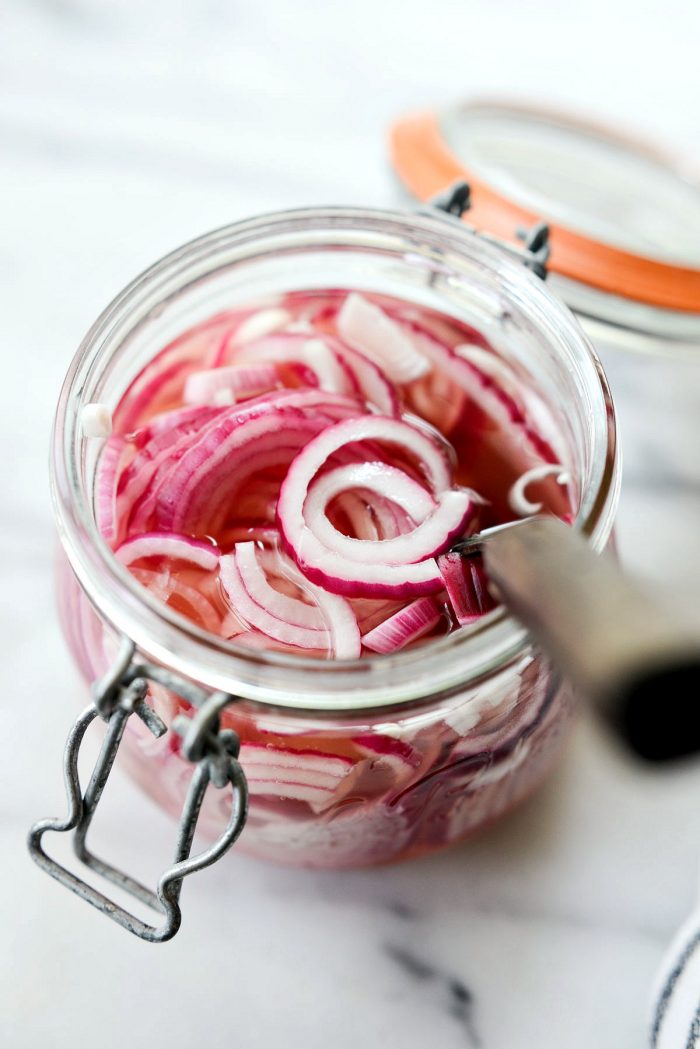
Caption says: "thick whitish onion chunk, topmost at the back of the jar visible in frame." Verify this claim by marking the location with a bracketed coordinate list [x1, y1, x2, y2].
[337, 292, 431, 383]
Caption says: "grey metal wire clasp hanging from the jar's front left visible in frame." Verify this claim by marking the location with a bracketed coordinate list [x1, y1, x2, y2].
[28, 639, 248, 943]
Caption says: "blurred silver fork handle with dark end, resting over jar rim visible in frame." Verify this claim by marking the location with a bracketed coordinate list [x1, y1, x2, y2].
[484, 518, 700, 761]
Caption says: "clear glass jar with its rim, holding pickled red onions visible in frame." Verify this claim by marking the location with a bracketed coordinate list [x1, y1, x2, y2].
[52, 208, 619, 868]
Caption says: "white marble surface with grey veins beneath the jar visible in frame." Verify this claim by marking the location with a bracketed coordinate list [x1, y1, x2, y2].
[0, 0, 700, 1049]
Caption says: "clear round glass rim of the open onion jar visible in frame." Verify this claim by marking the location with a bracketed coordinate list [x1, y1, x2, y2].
[56, 207, 620, 713]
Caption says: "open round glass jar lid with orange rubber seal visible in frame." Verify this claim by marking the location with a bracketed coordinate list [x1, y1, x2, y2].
[390, 102, 700, 316]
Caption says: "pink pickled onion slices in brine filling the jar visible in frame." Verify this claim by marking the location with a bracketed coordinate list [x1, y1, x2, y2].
[56, 291, 576, 866]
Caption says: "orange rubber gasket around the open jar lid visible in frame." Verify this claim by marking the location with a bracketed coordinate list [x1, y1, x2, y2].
[389, 112, 700, 313]
